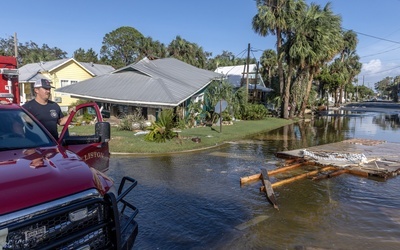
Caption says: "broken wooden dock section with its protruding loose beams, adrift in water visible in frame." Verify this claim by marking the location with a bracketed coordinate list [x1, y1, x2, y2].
[240, 139, 400, 209]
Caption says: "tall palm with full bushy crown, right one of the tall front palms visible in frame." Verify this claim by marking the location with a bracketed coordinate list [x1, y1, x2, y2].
[288, 3, 342, 116]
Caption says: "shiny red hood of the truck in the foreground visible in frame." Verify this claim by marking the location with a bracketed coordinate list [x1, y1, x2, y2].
[0, 146, 113, 215]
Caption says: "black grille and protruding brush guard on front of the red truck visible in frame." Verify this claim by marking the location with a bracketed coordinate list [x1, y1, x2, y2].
[0, 177, 139, 250]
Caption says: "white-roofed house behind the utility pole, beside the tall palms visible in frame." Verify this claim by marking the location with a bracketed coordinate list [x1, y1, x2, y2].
[215, 64, 273, 102]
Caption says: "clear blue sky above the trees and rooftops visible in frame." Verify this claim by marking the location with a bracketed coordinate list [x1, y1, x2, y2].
[0, 0, 400, 87]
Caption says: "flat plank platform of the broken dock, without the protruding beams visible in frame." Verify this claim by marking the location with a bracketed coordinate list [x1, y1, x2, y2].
[276, 139, 400, 179]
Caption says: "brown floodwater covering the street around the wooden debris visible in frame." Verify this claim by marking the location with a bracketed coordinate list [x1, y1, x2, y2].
[108, 111, 400, 250]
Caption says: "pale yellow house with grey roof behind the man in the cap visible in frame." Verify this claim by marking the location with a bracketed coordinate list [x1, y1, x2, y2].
[19, 58, 114, 111]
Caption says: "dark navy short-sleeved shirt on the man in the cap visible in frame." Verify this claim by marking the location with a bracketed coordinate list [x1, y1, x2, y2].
[23, 99, 64, 140]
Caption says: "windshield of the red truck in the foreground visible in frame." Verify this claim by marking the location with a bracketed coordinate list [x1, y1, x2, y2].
[0, 110, 56, 151]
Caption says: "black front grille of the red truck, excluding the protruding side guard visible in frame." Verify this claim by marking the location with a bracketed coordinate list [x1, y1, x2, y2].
[0, 191, 115, 250]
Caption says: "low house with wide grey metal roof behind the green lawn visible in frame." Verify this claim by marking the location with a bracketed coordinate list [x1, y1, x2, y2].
[56, 58, 221, 120]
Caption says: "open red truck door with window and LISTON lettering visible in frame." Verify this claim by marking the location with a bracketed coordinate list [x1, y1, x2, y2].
[58, 103, 110, 172]
